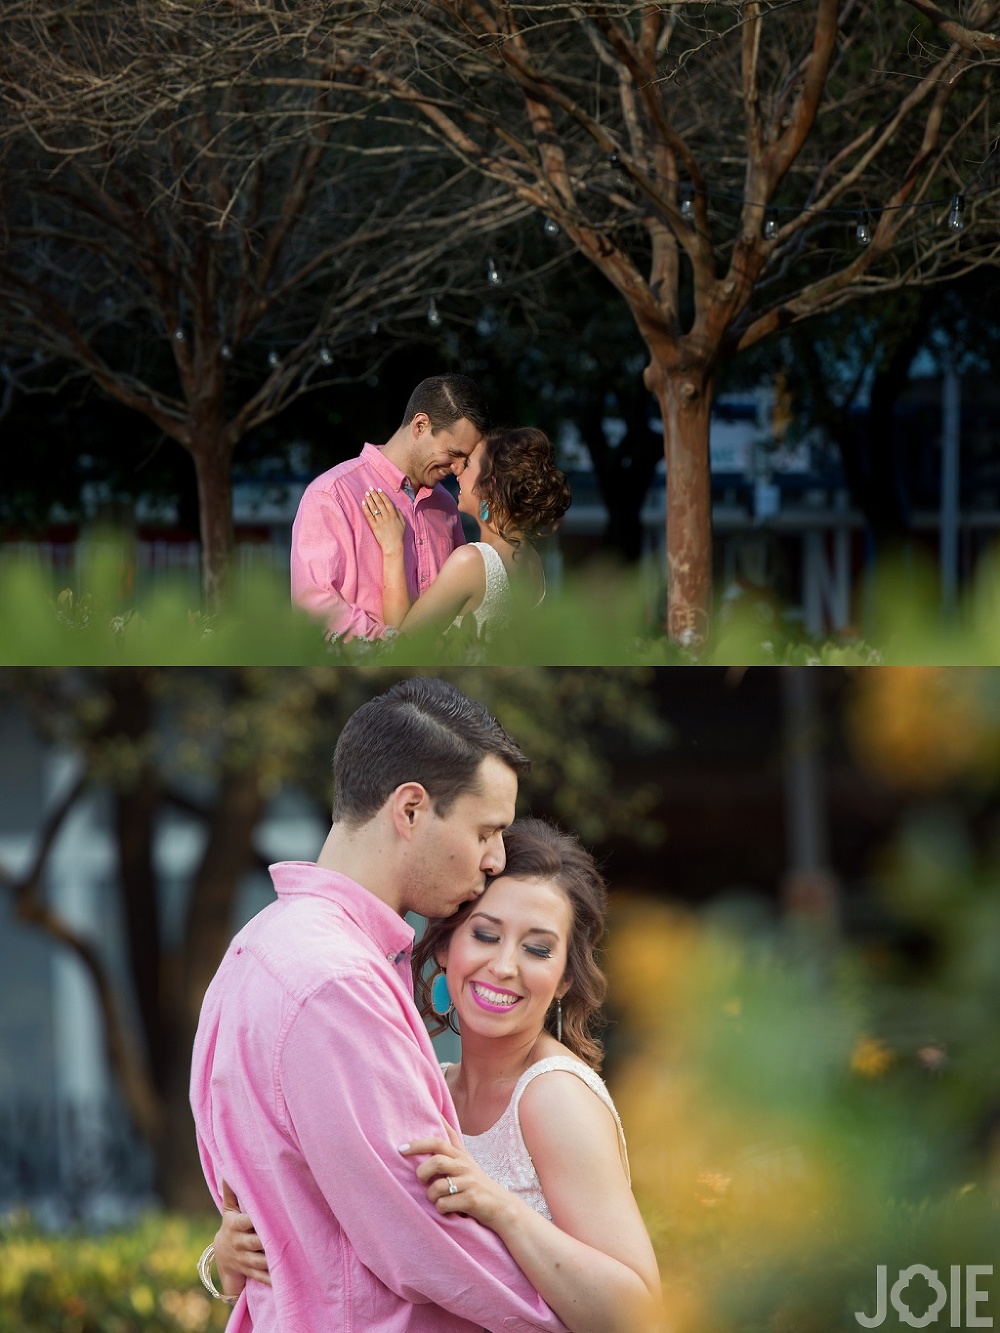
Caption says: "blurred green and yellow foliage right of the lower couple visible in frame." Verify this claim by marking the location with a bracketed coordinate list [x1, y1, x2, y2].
[611, 878, 1000, 1333]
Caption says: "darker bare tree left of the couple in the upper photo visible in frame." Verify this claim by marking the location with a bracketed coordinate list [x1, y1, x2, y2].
[0, 0, 527, 607]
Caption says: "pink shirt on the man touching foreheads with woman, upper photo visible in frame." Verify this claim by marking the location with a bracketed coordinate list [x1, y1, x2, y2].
[292, 444, 465, 639]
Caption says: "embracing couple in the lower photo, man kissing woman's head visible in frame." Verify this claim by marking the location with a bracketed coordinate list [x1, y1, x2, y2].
[192, 678, 659, 1333]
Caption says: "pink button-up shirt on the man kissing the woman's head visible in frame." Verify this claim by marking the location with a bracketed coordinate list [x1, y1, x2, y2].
[191, 861, 563, 1333]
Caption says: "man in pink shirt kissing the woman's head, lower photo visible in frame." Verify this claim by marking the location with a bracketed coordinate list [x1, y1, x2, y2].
[191, 678, 563, 1333]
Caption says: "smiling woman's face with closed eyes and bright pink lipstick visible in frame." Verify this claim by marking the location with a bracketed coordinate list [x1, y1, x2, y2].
[437, 876, 573, 1037]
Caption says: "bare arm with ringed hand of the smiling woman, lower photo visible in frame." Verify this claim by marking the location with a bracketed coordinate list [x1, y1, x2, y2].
[407, 1093, 661, 1333]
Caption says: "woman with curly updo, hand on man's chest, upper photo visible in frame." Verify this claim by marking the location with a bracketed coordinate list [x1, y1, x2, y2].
[364, 427, 569, 643]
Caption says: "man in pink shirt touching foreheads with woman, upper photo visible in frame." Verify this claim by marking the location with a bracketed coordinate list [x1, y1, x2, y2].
[292, 375, 488, 639]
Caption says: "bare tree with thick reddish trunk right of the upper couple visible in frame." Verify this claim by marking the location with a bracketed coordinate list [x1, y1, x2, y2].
[305, 0, 1000, 645]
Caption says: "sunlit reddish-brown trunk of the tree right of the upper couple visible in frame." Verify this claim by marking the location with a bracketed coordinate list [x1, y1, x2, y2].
[644, 361, 712, 651]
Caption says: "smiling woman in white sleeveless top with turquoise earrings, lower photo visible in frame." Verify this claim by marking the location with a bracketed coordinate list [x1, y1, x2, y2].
[215, 820, 661, 1333]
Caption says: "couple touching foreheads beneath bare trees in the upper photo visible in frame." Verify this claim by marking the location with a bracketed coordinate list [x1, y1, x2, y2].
[291, 375, 569, 643]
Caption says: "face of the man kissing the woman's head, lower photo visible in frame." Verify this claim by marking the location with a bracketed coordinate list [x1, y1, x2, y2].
[403, 754, 517, 917]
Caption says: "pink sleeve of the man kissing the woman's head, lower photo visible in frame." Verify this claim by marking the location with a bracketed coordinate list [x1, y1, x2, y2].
[279, 974, 564, 1330]
